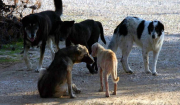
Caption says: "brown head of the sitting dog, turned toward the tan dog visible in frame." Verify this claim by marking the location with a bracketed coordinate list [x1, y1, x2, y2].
[75, 44, 94, 64]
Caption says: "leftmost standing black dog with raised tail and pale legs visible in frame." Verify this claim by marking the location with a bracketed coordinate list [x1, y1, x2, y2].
[22, 0, 73, 71]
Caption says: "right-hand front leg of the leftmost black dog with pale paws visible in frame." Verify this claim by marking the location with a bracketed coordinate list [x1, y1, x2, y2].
[35, 43, 46, 72]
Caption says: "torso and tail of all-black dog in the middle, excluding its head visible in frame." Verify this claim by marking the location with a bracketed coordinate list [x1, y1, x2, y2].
[70, 19, 106, 47]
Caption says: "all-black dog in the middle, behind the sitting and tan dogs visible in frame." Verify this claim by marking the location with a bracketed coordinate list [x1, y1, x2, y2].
[63, 20, 106, 74]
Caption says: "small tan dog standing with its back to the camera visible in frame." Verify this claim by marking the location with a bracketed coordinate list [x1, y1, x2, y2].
[91, 43, 119, 97]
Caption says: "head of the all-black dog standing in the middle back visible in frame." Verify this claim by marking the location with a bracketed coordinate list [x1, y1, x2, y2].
[57, 21, 74, 41]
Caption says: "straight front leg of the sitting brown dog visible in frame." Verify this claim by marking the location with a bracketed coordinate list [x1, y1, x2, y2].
[67, 70, 76, 98]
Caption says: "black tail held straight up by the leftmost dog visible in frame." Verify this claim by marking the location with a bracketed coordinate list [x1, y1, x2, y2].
[54, 0, 63, 16]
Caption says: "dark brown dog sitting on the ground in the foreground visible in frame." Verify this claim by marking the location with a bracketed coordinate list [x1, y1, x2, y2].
[38, 44, 94, 98]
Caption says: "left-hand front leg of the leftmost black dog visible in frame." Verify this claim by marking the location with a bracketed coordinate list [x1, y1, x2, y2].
[23, 45, 32, 70]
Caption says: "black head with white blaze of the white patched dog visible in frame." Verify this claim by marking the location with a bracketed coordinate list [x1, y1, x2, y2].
[148, 21, 164, 39]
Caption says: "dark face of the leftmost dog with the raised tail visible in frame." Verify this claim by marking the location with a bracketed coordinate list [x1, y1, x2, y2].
[22, 14, 39, 42]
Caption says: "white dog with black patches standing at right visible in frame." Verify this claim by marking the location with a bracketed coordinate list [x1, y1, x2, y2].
[108, 16, 164, 76]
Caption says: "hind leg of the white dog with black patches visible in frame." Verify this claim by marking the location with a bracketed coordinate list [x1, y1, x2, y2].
[121, 40, 133, 74]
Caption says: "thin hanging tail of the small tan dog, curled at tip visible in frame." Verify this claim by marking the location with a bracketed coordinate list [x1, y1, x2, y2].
[111, 62, 119, 83]
